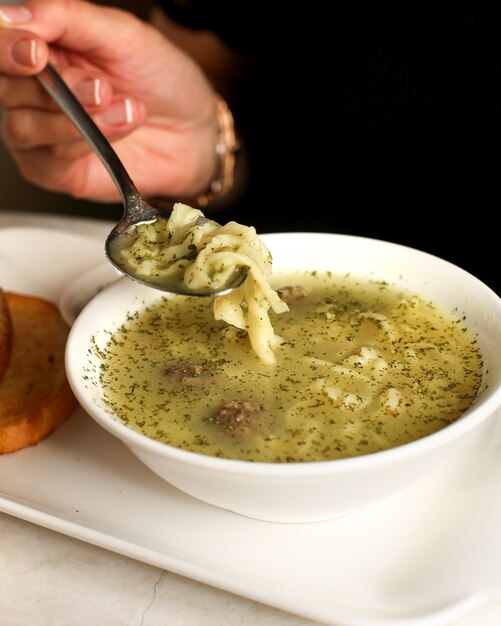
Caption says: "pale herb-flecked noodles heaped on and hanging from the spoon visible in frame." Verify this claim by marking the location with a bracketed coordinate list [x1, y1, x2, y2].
[112, 203, 289, 365]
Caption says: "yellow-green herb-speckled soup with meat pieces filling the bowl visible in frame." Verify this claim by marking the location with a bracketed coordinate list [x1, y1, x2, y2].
[95, 272, 482, 462]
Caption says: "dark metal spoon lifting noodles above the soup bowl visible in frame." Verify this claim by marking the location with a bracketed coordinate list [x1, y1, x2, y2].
[37, 63, 247, 296]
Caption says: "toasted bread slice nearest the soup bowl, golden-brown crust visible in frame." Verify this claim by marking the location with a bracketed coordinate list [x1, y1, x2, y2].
[0, 292, 77, 453]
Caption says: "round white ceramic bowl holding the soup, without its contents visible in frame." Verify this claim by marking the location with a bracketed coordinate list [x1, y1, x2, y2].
[66, 233, 501, 522]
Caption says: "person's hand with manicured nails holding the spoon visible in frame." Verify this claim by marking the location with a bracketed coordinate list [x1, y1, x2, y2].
[0, 0, 217, 201]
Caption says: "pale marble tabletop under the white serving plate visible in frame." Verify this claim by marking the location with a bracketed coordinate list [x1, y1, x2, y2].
[0, 212, 501, 626]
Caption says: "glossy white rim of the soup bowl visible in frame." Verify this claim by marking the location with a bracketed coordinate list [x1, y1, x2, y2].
[65, 232, 501, 478]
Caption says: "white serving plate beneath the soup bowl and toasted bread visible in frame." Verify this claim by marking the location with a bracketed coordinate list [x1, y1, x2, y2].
[0, 218, 501, 626]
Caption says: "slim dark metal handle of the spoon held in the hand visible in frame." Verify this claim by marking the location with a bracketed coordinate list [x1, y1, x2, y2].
[37, 63, 140, 206]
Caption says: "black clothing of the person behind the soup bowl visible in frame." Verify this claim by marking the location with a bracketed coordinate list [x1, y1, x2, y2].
[163, 0, 501, 294]
